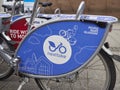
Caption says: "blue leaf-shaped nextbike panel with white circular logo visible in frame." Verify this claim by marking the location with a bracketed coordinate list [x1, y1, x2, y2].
[16, 20, 107, 76]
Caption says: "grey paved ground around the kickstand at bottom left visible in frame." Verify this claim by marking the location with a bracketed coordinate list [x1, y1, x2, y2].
[0, 75, 40, 90]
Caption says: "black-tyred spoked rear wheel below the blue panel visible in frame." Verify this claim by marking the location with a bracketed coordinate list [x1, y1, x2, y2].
[35, 50, 116, 90]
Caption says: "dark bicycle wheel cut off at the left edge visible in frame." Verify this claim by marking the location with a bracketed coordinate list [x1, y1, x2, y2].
[0, 37, 14, 80]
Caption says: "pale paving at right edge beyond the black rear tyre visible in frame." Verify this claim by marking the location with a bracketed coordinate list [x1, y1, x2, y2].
[107, 23, 120, 90]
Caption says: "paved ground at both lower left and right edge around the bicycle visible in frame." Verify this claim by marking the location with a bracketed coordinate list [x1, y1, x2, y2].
[0, 23, 120, 90]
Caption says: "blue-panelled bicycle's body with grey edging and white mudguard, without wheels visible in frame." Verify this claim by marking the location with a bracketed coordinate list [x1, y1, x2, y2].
[0, 0, 117, 89]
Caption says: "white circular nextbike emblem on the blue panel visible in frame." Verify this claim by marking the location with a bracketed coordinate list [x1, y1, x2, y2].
[43, 35, 72, 64]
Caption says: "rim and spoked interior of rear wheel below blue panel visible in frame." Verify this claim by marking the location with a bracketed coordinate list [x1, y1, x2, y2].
[38, 55, 111, 90]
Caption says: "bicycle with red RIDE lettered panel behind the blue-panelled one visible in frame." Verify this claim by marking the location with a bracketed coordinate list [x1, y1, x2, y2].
[0, 0, 51, 80]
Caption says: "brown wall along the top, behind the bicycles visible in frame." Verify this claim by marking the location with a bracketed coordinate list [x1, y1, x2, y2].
[40, 0, 120, 18]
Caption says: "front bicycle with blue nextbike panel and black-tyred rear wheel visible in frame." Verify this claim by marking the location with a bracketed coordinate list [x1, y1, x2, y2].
[0, 0, 117, 90]
